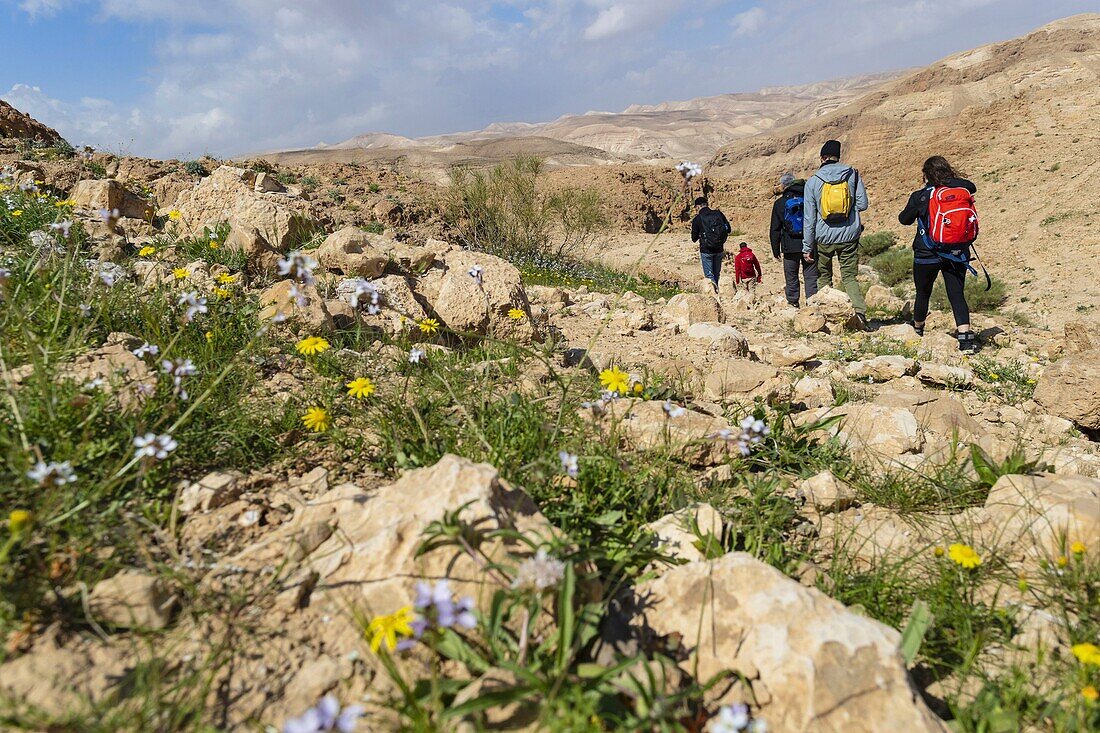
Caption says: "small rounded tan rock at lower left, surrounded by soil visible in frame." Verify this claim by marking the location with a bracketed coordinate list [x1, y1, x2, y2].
[88, 570, 176, 630]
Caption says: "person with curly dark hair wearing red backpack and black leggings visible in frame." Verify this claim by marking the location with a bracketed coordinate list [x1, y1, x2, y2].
[898, 155, 978, 353]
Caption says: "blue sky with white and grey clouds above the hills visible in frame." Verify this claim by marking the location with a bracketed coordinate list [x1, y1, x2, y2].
[0, 0, 1096, 158]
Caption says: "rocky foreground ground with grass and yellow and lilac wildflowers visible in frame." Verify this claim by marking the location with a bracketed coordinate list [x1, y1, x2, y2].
[0, 138, 1100, 733]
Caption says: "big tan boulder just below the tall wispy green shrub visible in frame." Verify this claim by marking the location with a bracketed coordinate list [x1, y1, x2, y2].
[435, 250, 539, 341]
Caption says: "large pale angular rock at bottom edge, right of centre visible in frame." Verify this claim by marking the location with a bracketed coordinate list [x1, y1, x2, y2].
[638, 553, 946, 733]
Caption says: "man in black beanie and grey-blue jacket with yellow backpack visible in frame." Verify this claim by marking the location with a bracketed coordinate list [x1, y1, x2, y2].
[802, 140, 867, 329]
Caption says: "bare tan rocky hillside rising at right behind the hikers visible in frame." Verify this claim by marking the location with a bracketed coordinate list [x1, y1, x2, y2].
[707, 14, 1100, 316]
